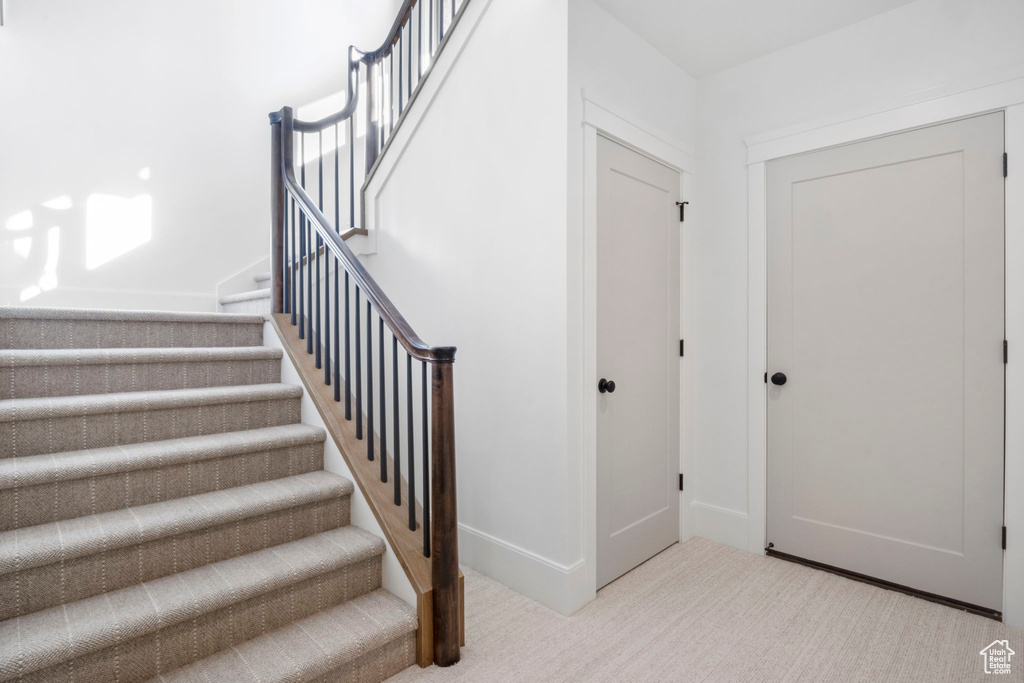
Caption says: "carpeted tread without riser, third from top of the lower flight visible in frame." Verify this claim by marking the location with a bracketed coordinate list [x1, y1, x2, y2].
[0, 384, 302, 422]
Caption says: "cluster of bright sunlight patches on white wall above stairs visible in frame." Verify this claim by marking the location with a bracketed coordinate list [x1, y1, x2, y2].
[0, 167, 153, 305]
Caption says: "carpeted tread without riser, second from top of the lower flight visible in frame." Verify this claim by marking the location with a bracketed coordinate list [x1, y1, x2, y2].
[0, 346, 283, 368]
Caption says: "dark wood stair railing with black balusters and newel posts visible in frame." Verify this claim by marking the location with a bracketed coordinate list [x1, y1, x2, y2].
[270, 0, 469, 666]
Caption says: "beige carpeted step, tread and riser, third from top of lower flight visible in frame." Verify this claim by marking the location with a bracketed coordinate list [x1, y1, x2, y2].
[0, 384, 302, 458]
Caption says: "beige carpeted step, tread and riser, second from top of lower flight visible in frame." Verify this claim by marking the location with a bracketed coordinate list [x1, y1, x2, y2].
[0, 346, 282, 400]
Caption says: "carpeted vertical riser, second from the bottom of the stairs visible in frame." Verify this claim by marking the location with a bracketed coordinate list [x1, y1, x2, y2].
[19, 557, 381, 683]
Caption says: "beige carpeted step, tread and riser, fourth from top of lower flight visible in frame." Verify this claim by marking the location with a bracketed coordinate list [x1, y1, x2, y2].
[0, 424, 326, 531]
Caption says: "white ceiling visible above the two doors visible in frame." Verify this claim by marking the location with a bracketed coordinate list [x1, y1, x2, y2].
[595, 0, 913, 78]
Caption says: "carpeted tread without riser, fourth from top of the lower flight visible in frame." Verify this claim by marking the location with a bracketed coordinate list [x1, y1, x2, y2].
[0, 424, 327, 490]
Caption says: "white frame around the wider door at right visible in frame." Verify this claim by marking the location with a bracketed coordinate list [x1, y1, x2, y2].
[744, 67, 1024, 627]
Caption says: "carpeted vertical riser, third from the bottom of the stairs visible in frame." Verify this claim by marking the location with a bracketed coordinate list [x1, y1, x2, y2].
[0, 496, 350, 621]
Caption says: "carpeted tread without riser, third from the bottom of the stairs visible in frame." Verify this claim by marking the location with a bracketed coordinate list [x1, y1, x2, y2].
[0, 470, 353, 574]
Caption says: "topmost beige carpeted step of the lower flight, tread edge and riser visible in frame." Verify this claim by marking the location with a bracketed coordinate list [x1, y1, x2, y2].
[0, 306, 263, 349]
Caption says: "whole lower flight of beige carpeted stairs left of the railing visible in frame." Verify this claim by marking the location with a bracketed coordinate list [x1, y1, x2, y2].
[0, 308, 417, 683]
